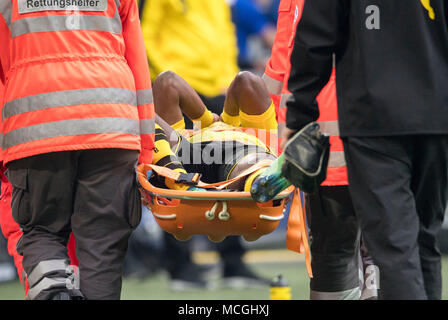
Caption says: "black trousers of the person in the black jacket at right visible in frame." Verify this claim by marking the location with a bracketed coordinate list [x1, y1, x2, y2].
[343, 135, 448, 299]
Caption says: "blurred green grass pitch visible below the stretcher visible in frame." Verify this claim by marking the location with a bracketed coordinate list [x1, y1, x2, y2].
[0, 250, 448, 300]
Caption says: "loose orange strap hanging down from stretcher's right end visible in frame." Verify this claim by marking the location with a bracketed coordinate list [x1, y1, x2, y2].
[286, 189, 313, 278]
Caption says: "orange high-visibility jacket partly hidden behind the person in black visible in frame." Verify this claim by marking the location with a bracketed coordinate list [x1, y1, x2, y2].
[263, 0, 348, 186]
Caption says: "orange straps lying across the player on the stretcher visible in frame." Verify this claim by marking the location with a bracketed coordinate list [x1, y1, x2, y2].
[145, 160, 273, 190]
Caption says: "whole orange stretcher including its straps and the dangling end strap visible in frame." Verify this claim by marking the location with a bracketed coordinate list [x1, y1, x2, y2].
[137, 130, 312, 277]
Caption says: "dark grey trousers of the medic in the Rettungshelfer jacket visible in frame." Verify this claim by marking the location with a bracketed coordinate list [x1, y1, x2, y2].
[7, 149, 141, 299]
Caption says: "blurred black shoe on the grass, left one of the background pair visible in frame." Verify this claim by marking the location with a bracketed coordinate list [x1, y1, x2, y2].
[170, 263, 215, 291]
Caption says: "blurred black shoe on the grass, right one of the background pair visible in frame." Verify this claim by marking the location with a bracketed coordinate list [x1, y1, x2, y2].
[221, 263, 271, 289]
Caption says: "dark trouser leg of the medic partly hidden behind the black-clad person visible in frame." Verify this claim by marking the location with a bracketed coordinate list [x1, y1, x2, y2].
[305, 186, 360, 299]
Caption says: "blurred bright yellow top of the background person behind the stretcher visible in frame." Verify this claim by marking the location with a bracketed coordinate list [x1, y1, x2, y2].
[140, 0, 239, 97]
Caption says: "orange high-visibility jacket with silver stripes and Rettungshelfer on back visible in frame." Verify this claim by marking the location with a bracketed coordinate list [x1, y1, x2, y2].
[0, 0, 154, 163]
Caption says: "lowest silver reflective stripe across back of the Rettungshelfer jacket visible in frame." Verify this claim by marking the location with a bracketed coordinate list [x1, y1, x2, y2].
[3, 118, 140, 149]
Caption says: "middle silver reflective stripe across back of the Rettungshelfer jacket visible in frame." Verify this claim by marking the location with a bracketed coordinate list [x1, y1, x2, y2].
[2, 88, 137, 120]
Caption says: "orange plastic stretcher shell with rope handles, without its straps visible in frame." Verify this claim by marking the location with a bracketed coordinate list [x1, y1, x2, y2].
[138, 166, 294, 242]
